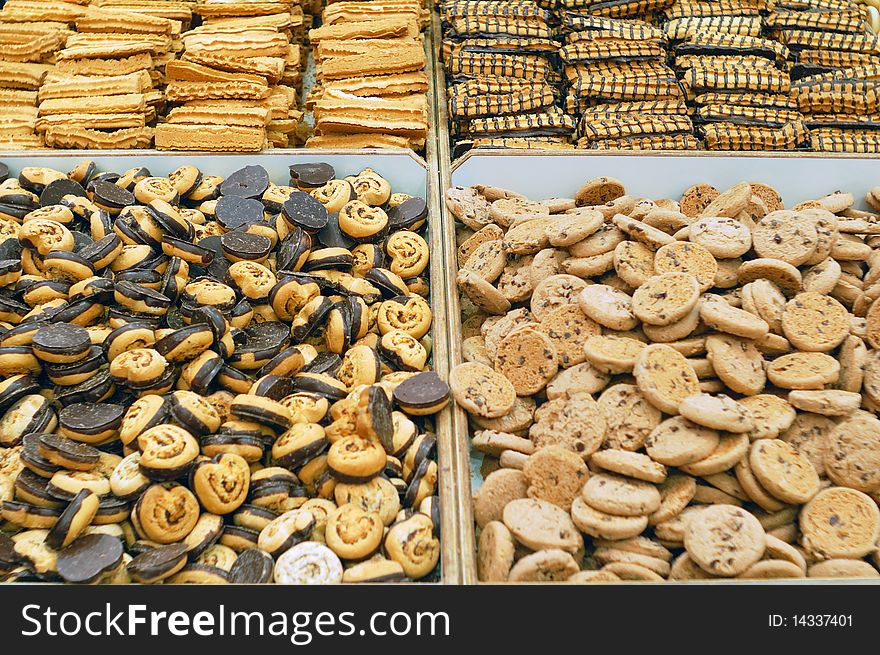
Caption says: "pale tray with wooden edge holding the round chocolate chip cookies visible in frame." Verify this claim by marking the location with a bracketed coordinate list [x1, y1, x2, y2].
[438, 150, 880, 584]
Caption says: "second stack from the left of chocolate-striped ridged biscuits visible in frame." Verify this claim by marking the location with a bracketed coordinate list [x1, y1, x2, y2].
[560, 13, 698, 150]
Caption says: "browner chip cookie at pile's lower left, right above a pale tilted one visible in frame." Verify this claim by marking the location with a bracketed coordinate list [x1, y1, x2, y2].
[522, 445, 590, 512]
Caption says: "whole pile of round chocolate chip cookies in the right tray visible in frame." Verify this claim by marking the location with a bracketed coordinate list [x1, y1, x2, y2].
[446, 177, 880, 582]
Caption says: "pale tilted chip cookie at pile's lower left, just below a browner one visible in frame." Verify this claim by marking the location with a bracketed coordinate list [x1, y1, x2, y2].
[503, 498, 584, 554]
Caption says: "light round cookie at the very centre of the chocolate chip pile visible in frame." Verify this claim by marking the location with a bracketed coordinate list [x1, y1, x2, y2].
[632, 342, 699, 414]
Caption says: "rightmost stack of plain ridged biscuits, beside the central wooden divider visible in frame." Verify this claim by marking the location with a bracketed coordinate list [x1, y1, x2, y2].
[306, 0, 429, 150]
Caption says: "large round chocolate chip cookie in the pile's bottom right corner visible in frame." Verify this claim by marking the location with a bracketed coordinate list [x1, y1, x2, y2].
[799, 487, 880, 559]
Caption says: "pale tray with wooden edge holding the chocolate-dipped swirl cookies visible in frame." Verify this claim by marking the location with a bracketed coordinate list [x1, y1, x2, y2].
[0, 152, 462, 584]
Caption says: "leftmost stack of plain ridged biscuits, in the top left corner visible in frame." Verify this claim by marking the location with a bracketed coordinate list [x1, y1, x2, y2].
[0, 0, 76, 150]
